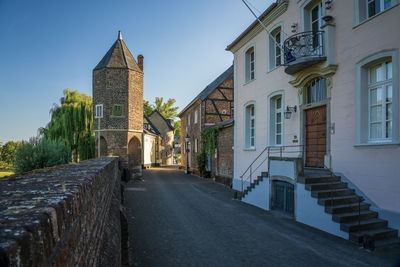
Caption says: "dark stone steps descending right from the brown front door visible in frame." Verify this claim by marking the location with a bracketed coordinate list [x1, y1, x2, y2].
[299, 172, 400, 249]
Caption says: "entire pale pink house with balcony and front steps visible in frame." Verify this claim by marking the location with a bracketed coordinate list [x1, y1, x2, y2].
[227, 0, 400, 248]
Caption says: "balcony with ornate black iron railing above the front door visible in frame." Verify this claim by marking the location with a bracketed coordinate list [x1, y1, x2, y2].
[283, 31, 326, 74]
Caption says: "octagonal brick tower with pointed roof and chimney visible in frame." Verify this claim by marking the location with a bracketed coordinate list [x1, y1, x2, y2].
[93, 31, 143, 171]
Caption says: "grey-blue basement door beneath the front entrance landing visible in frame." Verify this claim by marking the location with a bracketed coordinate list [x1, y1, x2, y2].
[272, 181, 294, 216]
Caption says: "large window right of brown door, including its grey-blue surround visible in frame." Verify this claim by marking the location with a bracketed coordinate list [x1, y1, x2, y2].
[355, 49, 399, 146]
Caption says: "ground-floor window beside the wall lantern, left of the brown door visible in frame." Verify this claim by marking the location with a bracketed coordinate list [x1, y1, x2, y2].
[268, 92, 284, 146]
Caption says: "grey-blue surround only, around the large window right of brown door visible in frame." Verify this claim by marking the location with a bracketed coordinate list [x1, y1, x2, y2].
[354, 48, 400, 147]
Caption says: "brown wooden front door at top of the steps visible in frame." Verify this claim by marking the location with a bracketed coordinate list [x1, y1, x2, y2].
[305, 106, 326, 168]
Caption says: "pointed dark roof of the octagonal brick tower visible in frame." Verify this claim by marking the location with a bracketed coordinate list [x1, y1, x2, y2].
[94, 31, 142, 72]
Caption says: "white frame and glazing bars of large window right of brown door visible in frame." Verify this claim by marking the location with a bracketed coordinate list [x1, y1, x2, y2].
[368, 61, 393, 142]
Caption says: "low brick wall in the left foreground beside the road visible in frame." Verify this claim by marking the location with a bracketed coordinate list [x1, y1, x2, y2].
[0, 158, 125, 266]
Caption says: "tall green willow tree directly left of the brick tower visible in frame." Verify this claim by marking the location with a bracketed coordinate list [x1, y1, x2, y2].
[42, 88, 95, 162]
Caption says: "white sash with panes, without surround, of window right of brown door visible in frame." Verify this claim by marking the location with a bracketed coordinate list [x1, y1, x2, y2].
[368, 61, 393, 141]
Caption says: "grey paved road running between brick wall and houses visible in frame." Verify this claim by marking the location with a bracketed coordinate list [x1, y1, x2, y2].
[125, 168, 400, 267]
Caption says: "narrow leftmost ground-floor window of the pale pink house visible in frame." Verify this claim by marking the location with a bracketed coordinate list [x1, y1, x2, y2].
[244, 101, 256, 150]
